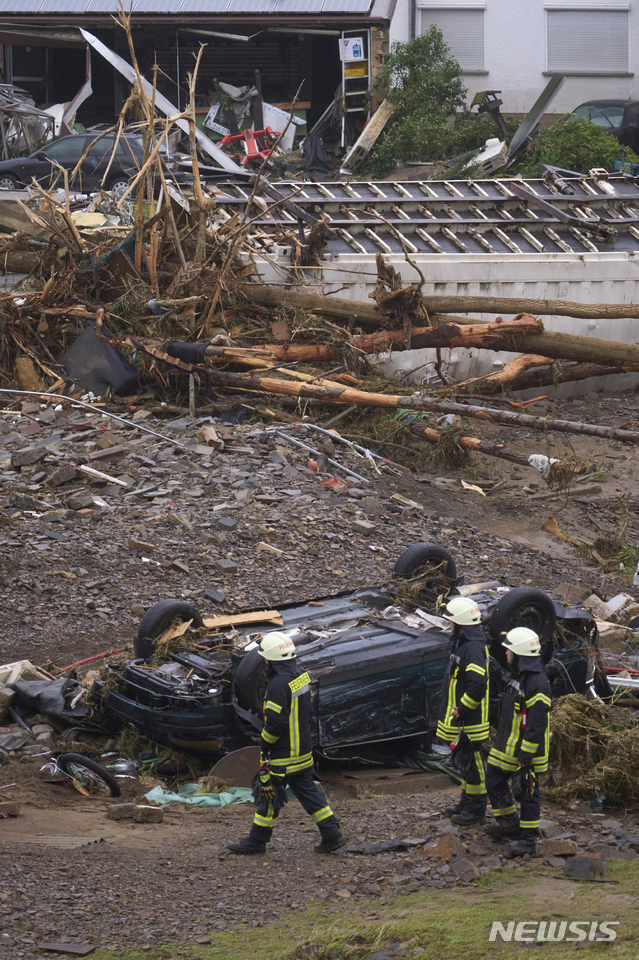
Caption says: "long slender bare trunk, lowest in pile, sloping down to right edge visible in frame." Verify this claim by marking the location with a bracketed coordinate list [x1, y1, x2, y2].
[211, 369, 639, 443]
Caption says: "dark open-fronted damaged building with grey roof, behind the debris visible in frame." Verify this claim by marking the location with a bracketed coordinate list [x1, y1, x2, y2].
[0, 0, 395, 125]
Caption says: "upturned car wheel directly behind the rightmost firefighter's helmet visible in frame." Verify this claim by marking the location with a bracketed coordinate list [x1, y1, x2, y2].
[488, 587, 557, 664]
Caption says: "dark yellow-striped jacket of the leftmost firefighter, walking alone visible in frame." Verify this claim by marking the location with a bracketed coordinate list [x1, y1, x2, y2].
[261, 660, 313, 777]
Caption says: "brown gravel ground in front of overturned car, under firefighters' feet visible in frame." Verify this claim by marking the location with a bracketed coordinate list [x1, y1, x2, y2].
[0, 790, 637, 960]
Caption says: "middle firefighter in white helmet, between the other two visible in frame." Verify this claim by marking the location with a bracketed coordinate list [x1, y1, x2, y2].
[437, 597, 488, 826]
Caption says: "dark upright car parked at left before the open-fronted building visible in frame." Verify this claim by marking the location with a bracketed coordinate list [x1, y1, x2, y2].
[0, 134, 155, 197]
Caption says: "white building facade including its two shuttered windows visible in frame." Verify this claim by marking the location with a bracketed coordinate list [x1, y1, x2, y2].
[390, 0, 639, 115]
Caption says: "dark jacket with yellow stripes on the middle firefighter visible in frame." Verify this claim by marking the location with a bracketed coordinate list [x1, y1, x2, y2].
[437, 624, 488, 743]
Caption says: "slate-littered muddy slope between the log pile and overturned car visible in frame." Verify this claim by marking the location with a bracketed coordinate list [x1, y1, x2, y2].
[0, 384, 639, 666]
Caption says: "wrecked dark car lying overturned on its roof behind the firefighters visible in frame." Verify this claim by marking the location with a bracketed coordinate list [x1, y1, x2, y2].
[94, 543, 597, 756]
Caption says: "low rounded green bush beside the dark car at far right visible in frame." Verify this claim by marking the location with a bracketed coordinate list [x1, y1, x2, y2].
[508, 117, 639, 177]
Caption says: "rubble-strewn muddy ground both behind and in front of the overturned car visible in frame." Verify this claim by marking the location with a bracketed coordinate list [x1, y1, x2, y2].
[0, 393, 639, 960]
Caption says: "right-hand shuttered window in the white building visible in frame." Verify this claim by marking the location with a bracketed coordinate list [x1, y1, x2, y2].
[546, 7, 629, 73]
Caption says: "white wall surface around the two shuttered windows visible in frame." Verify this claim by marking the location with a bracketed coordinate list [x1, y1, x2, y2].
[390, 0, 639, 113]
